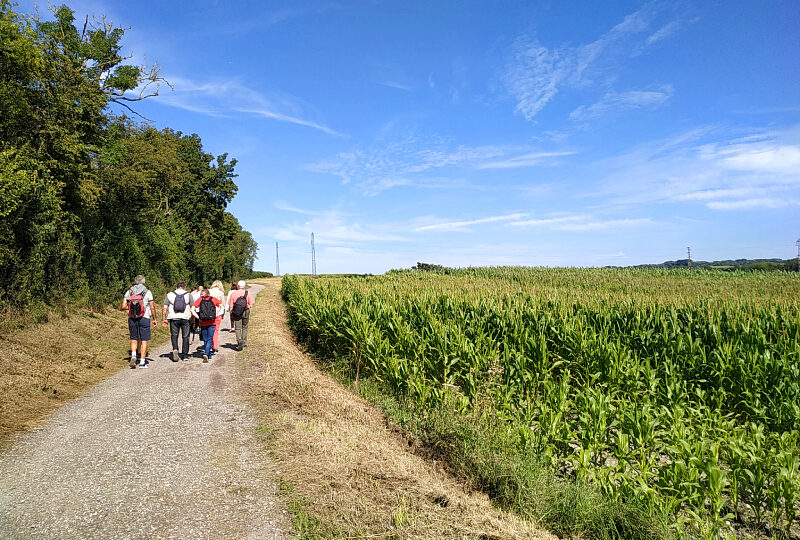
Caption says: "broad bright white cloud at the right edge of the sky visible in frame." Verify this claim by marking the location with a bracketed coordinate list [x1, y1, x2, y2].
[589, 127, 800, 210]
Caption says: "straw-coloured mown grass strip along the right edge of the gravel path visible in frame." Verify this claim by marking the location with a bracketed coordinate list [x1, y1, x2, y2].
[240, 279, 552, 538]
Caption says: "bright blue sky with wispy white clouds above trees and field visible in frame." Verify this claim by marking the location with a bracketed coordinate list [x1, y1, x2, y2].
[22, 0, 800, 273]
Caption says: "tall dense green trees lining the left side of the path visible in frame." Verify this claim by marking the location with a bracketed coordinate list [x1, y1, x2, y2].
[0, 0, 257, 307]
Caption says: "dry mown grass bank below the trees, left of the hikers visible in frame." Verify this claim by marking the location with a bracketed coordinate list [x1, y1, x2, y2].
[0, 309, 169, 448]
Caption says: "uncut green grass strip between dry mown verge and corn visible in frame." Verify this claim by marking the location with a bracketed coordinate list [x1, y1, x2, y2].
[354, 376, 671, 540]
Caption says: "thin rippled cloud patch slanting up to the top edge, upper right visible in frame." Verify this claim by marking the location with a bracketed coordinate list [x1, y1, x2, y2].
[504, 2, 685, 120]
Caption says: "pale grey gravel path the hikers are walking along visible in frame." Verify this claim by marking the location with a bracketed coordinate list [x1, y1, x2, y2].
[0, 286, 290, 539]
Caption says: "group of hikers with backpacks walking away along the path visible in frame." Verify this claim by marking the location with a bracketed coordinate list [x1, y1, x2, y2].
[120, 275, 255, 369]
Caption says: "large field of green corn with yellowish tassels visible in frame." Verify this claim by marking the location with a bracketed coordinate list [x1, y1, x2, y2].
[283, 268, 800, 538]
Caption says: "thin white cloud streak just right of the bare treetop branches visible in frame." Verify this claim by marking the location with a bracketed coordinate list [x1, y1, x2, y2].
[158, 77, 342, 136]
